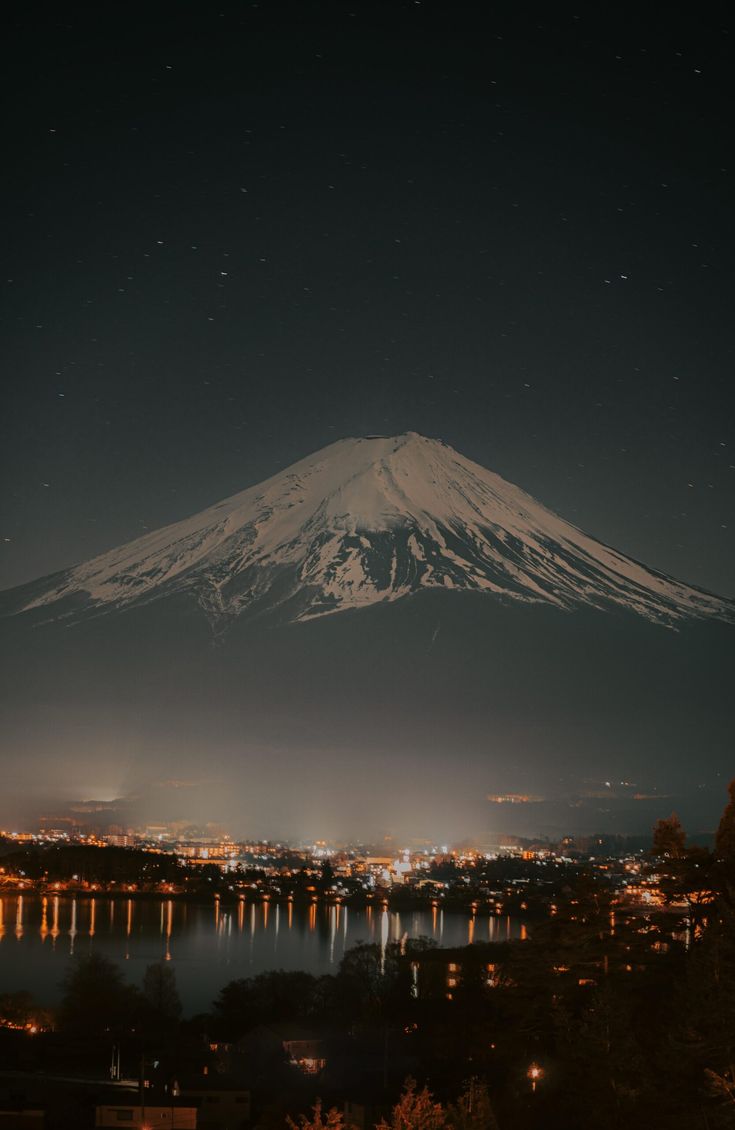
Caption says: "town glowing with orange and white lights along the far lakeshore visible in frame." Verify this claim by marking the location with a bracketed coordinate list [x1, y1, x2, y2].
[0, 825, 662, 914]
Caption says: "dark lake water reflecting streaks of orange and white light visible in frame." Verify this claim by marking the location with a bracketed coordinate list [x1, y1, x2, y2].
[0, 895, 522, 1015]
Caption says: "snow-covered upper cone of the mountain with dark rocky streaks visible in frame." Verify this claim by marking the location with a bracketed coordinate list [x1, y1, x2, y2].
[7, 432, 735, 628]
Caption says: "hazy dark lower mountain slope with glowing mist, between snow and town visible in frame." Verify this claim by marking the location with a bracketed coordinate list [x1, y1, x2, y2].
[0, 592, 735, 842]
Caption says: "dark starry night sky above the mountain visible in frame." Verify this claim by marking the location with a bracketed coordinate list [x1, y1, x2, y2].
[0, 0, 735, 594]
